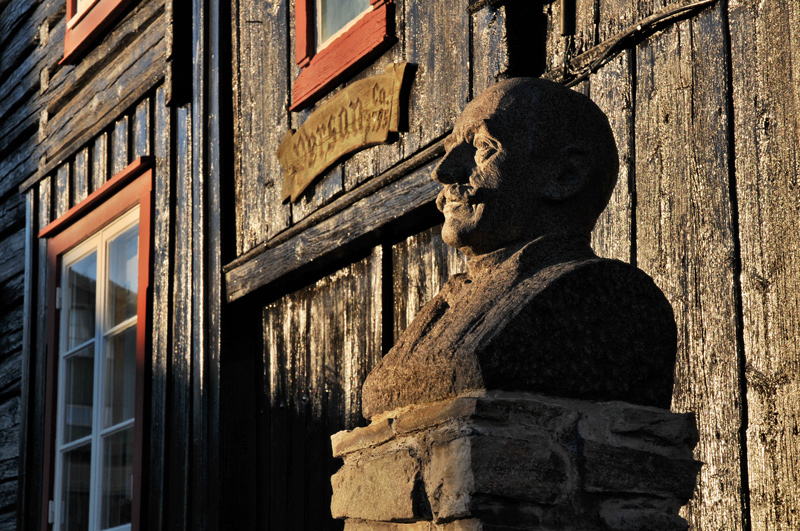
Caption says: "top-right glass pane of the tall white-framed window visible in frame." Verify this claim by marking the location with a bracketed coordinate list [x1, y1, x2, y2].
[106, 225, 139, 328]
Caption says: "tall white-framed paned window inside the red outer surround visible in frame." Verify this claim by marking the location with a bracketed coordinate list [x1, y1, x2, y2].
[53, 207, 139, 531]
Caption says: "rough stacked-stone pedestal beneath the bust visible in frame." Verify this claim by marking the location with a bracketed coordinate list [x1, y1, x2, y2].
[331, 392, 700, 531]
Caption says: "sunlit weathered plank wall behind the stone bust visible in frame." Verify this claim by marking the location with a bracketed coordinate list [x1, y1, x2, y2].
[227, 0, 800, 531]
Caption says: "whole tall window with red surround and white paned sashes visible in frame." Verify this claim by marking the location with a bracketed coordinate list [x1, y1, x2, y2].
[39, 159, 152, 531]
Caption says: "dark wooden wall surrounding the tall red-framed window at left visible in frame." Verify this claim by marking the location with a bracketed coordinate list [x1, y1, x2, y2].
[0, 0, 230, 530]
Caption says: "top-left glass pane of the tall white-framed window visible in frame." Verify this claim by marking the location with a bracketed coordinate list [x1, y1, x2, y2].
[67, 253, 97, 350]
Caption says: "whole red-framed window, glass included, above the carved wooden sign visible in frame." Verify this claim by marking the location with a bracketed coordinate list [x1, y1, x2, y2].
[291, 0, 395, 110]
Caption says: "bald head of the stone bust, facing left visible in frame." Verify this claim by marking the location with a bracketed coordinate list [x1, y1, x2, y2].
[433, 78, 619, 256]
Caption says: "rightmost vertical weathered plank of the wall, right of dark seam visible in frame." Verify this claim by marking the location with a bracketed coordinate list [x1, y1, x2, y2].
[729, 0, 800, 531]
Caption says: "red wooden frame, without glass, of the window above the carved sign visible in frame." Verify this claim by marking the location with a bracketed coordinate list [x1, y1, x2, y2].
[290, 0, 397, 111]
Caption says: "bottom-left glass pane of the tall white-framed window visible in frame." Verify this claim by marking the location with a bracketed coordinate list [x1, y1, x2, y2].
[61, 444, 92, 531]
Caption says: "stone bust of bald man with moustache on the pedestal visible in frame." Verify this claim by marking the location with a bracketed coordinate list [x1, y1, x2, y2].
[362, 78, 677, 418]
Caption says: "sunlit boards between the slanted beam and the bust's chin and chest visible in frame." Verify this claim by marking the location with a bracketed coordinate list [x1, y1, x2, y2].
[392, 225, 467, 343]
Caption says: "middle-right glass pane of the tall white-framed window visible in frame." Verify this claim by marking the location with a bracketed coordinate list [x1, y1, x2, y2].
[103, 325, 136, 428]
